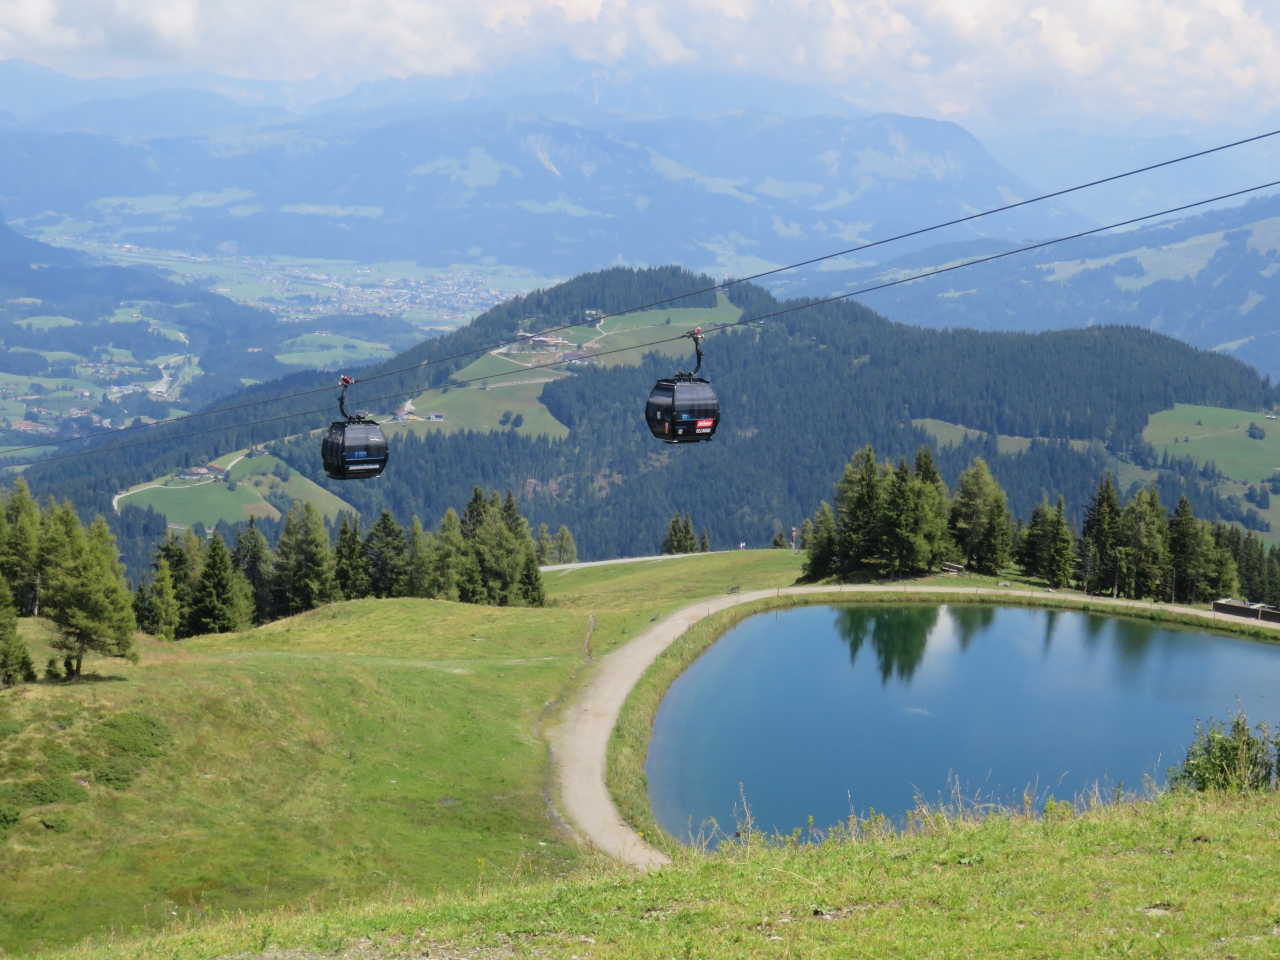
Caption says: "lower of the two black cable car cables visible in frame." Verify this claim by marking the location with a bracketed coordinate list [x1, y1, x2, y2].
[0, 180, 1280, 467]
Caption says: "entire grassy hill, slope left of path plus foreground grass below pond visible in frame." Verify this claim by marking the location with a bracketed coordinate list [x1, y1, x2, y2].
[0, 550, 1280, 960]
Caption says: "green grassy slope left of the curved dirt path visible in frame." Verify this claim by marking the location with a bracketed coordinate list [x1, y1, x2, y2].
[0, 550, 799, 951]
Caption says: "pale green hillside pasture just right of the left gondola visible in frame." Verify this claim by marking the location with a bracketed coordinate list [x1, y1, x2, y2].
[383, 384, 568, 439]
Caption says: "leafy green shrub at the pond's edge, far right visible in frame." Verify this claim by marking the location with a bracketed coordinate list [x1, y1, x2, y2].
[1169, 710, 1280, 792]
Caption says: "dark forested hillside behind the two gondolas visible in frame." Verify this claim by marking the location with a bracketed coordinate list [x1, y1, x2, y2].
[27, 268, 1275, 558]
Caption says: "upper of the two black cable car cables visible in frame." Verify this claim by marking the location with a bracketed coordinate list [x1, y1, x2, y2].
[8, 122, 1280, 463]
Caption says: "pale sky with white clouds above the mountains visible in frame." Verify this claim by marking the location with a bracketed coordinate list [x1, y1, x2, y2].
[0, 0, 1280, 132]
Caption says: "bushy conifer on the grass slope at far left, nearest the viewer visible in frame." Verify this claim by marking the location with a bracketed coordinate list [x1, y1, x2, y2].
[46, 517, 137, 680]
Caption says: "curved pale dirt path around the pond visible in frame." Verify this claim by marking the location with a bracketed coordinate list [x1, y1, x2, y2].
[549, 581, 1280, 869]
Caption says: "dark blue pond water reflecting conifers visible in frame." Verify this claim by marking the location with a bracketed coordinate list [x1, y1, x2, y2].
[645, 604, 1280, 837]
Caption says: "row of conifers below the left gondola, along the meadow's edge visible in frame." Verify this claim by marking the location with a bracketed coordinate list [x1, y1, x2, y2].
[133, 486, 577, 640]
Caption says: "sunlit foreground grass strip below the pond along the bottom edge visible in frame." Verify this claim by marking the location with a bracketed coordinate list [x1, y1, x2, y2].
[42, 795, 1280, 960]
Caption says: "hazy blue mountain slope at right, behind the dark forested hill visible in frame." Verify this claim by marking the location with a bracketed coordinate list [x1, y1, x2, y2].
[773, 196, 1280, 380]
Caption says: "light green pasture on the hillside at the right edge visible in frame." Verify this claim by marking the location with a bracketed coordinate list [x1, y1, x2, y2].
[1143, 403, 1280, 484]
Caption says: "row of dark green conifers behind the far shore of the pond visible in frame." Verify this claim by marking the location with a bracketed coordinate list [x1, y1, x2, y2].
[800, 447, 1280, 605]
